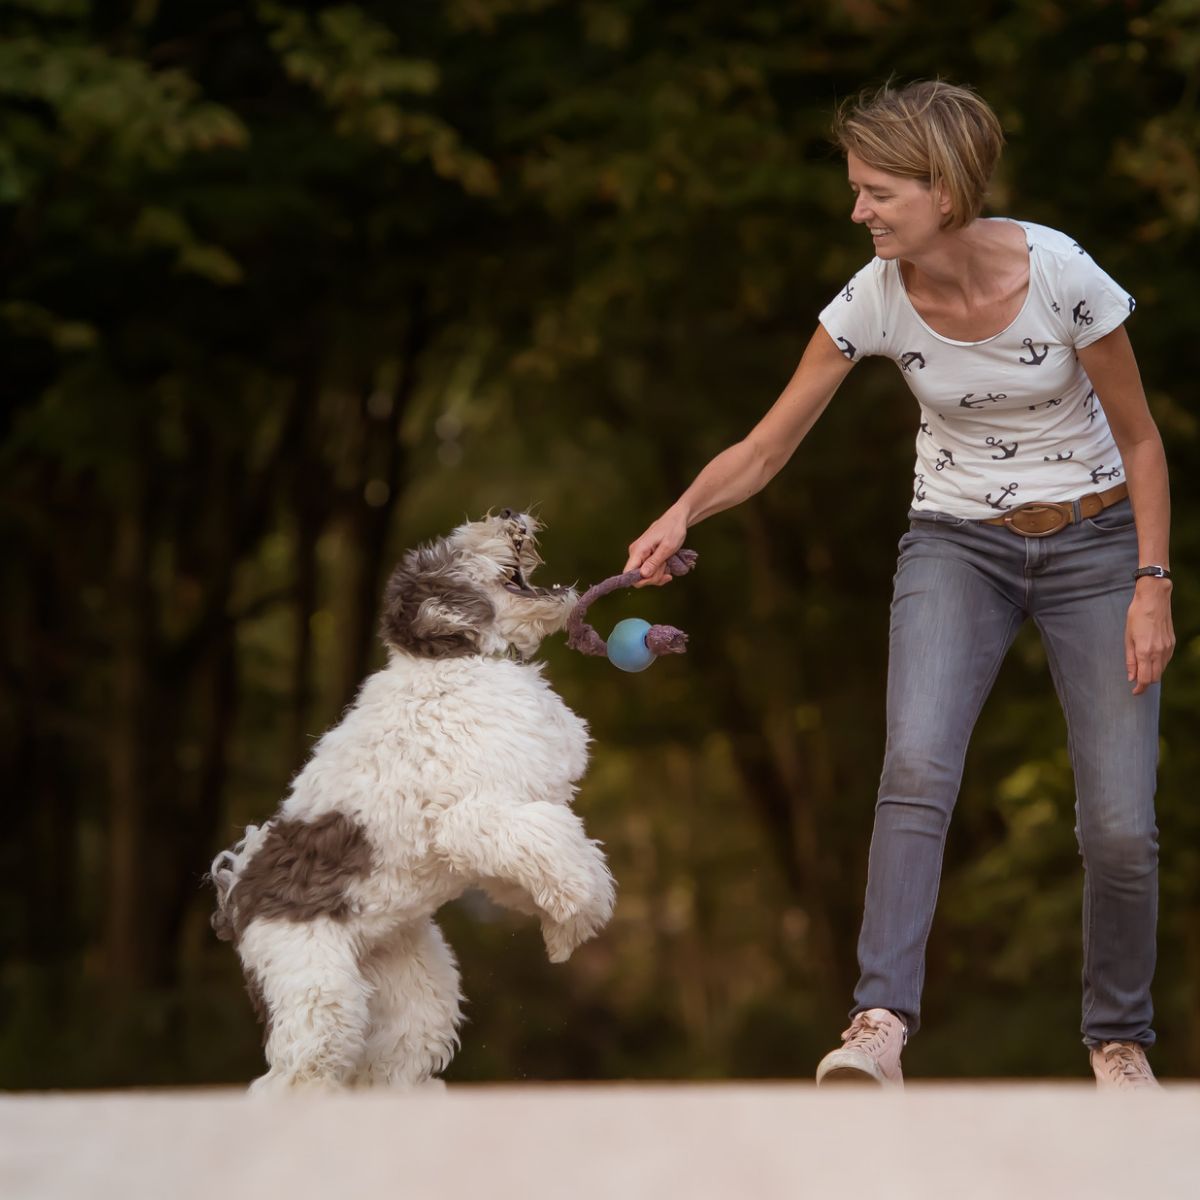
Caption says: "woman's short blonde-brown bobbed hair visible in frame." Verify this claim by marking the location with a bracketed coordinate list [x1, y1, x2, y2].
[833, 79, 1004, 229]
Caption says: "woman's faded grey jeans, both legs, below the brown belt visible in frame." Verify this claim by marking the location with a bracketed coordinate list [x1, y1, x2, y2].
[851, 500, 1159, 1045]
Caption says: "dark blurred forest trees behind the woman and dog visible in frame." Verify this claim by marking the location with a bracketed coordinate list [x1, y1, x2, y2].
[0, 0, 1200, 1088]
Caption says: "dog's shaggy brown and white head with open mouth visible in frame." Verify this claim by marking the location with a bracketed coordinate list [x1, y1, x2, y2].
[380, 509, 578, 659]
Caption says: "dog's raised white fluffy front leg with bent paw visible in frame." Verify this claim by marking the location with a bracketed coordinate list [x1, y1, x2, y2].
[434, 797, 616, 962]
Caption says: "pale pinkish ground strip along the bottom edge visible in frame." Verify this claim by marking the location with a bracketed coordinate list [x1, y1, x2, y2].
[0, 1084, 1200, 1200]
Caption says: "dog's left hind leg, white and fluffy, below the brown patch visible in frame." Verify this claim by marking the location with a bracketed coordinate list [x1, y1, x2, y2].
[238, 917, 371, 1093]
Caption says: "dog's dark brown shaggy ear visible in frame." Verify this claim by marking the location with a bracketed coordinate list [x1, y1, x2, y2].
[379, 544, 496, 659]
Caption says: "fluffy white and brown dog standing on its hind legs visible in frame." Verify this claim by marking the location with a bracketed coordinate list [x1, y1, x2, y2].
[210, 509, 614, 1093]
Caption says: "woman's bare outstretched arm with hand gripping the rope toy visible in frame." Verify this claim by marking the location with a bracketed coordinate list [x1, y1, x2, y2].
[625, 325, 853, 587]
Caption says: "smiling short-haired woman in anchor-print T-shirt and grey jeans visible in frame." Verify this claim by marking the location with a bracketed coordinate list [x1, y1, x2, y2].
[626, 82, 1175, 1087]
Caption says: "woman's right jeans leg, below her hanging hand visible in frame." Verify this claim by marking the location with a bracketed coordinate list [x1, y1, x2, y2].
[1033, 505, 1159, 1045]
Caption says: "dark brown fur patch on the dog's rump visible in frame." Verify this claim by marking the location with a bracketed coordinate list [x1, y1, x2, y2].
[228, 812, 372, 937]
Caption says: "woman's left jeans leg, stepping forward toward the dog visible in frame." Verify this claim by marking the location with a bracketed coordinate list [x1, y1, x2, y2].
[851, 521, 1025, 1032]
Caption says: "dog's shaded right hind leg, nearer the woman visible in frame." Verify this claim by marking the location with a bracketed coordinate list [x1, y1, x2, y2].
[356, 919, 462, 1087]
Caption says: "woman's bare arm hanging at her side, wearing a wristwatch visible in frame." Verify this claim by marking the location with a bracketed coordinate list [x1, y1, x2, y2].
[1079, 325, 1175, 696]
